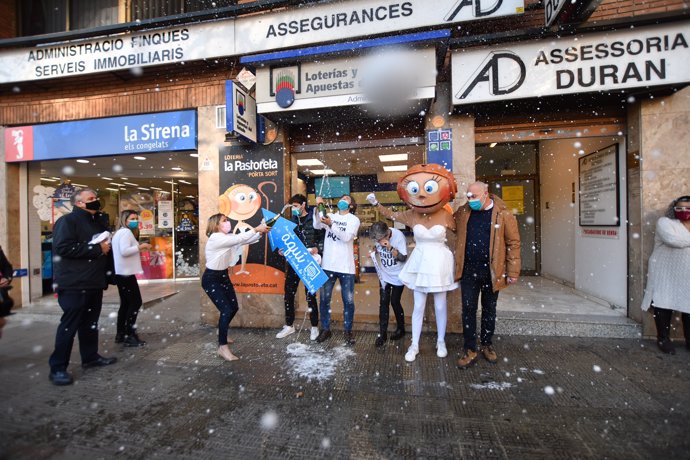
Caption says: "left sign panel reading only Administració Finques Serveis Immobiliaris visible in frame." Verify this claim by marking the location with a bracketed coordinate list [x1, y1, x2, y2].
[0, 21, 235, 84]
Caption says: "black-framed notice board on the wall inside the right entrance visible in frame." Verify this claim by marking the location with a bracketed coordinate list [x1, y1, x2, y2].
[578, 144, 620, 227]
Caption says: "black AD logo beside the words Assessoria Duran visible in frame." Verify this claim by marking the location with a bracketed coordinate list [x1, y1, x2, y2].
[455, 51, 527, 99]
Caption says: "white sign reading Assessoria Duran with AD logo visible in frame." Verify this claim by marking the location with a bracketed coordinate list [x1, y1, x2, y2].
[452, 22, 690, 105]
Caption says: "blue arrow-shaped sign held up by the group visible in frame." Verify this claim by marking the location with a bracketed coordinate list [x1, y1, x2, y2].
[261, 208, 328, 294]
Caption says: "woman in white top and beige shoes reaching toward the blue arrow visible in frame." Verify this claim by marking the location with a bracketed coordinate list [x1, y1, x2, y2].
[201, 214, 269, 361]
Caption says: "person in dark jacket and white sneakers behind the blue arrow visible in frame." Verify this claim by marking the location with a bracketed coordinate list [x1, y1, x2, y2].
[276, 194, 324, 340]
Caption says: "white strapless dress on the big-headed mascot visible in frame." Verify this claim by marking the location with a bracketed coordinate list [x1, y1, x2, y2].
[398, 224, 458, 292]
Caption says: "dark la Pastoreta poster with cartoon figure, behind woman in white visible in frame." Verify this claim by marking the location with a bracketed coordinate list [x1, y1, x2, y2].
[218, 144, 285, 294]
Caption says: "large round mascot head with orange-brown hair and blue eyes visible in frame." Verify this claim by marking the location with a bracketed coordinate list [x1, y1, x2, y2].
[398, 164, 458, 214]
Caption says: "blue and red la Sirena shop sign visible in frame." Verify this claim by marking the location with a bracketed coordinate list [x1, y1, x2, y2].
[5, 110, 197, 162]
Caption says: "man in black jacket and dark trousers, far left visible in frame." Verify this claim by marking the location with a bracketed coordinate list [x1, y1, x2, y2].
[49, 188, 117, 385]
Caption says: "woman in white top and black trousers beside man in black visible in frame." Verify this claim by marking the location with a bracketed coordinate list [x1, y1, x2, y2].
[112, 210, 151, 347]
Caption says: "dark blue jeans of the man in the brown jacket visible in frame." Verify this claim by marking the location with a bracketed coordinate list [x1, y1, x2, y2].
[460, 274, 498, 351]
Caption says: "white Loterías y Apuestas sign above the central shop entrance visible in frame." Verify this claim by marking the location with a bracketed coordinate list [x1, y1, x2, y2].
[256, 48, 436, 113]
